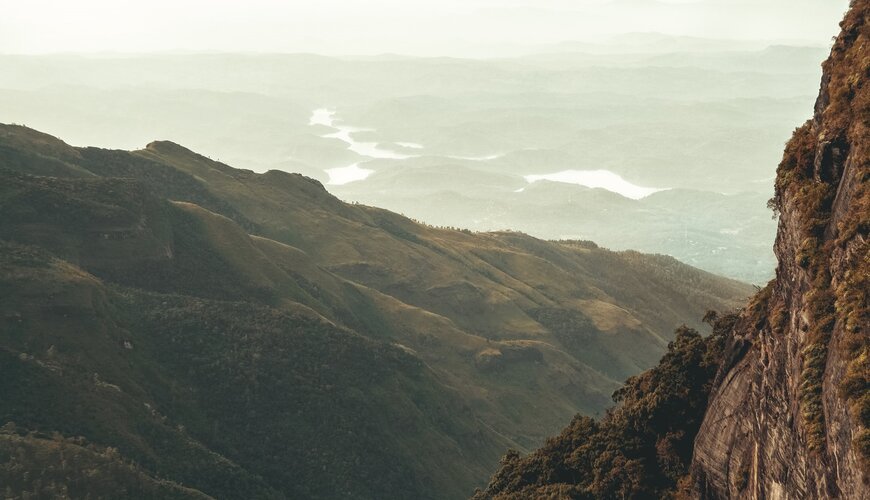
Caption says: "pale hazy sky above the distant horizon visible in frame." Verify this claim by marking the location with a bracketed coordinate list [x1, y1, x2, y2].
[0, 0, 848, 56]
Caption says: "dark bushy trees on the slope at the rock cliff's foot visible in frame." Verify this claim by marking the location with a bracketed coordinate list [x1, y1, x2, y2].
[475, 314, 736, 499]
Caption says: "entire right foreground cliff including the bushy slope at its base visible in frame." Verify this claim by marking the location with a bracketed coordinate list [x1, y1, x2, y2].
[476, 0, 870, 499]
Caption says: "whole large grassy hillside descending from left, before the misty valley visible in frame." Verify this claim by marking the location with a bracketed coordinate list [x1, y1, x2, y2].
[0, 125, 752, 498]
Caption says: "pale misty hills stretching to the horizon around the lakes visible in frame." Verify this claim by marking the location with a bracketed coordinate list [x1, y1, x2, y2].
[0, 35, 825, 283]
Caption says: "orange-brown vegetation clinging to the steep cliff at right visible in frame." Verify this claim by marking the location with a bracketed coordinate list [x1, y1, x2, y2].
[771, 0, 870, 459]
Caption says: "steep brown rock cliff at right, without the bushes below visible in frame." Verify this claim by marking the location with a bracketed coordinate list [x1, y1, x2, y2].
[692, 0, 870, 499]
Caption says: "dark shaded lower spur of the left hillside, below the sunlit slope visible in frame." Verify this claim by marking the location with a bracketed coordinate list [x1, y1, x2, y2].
[0, 242, 486, 498]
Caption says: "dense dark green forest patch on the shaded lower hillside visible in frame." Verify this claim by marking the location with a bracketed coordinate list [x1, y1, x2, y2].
[127, 295, 461, 498]
